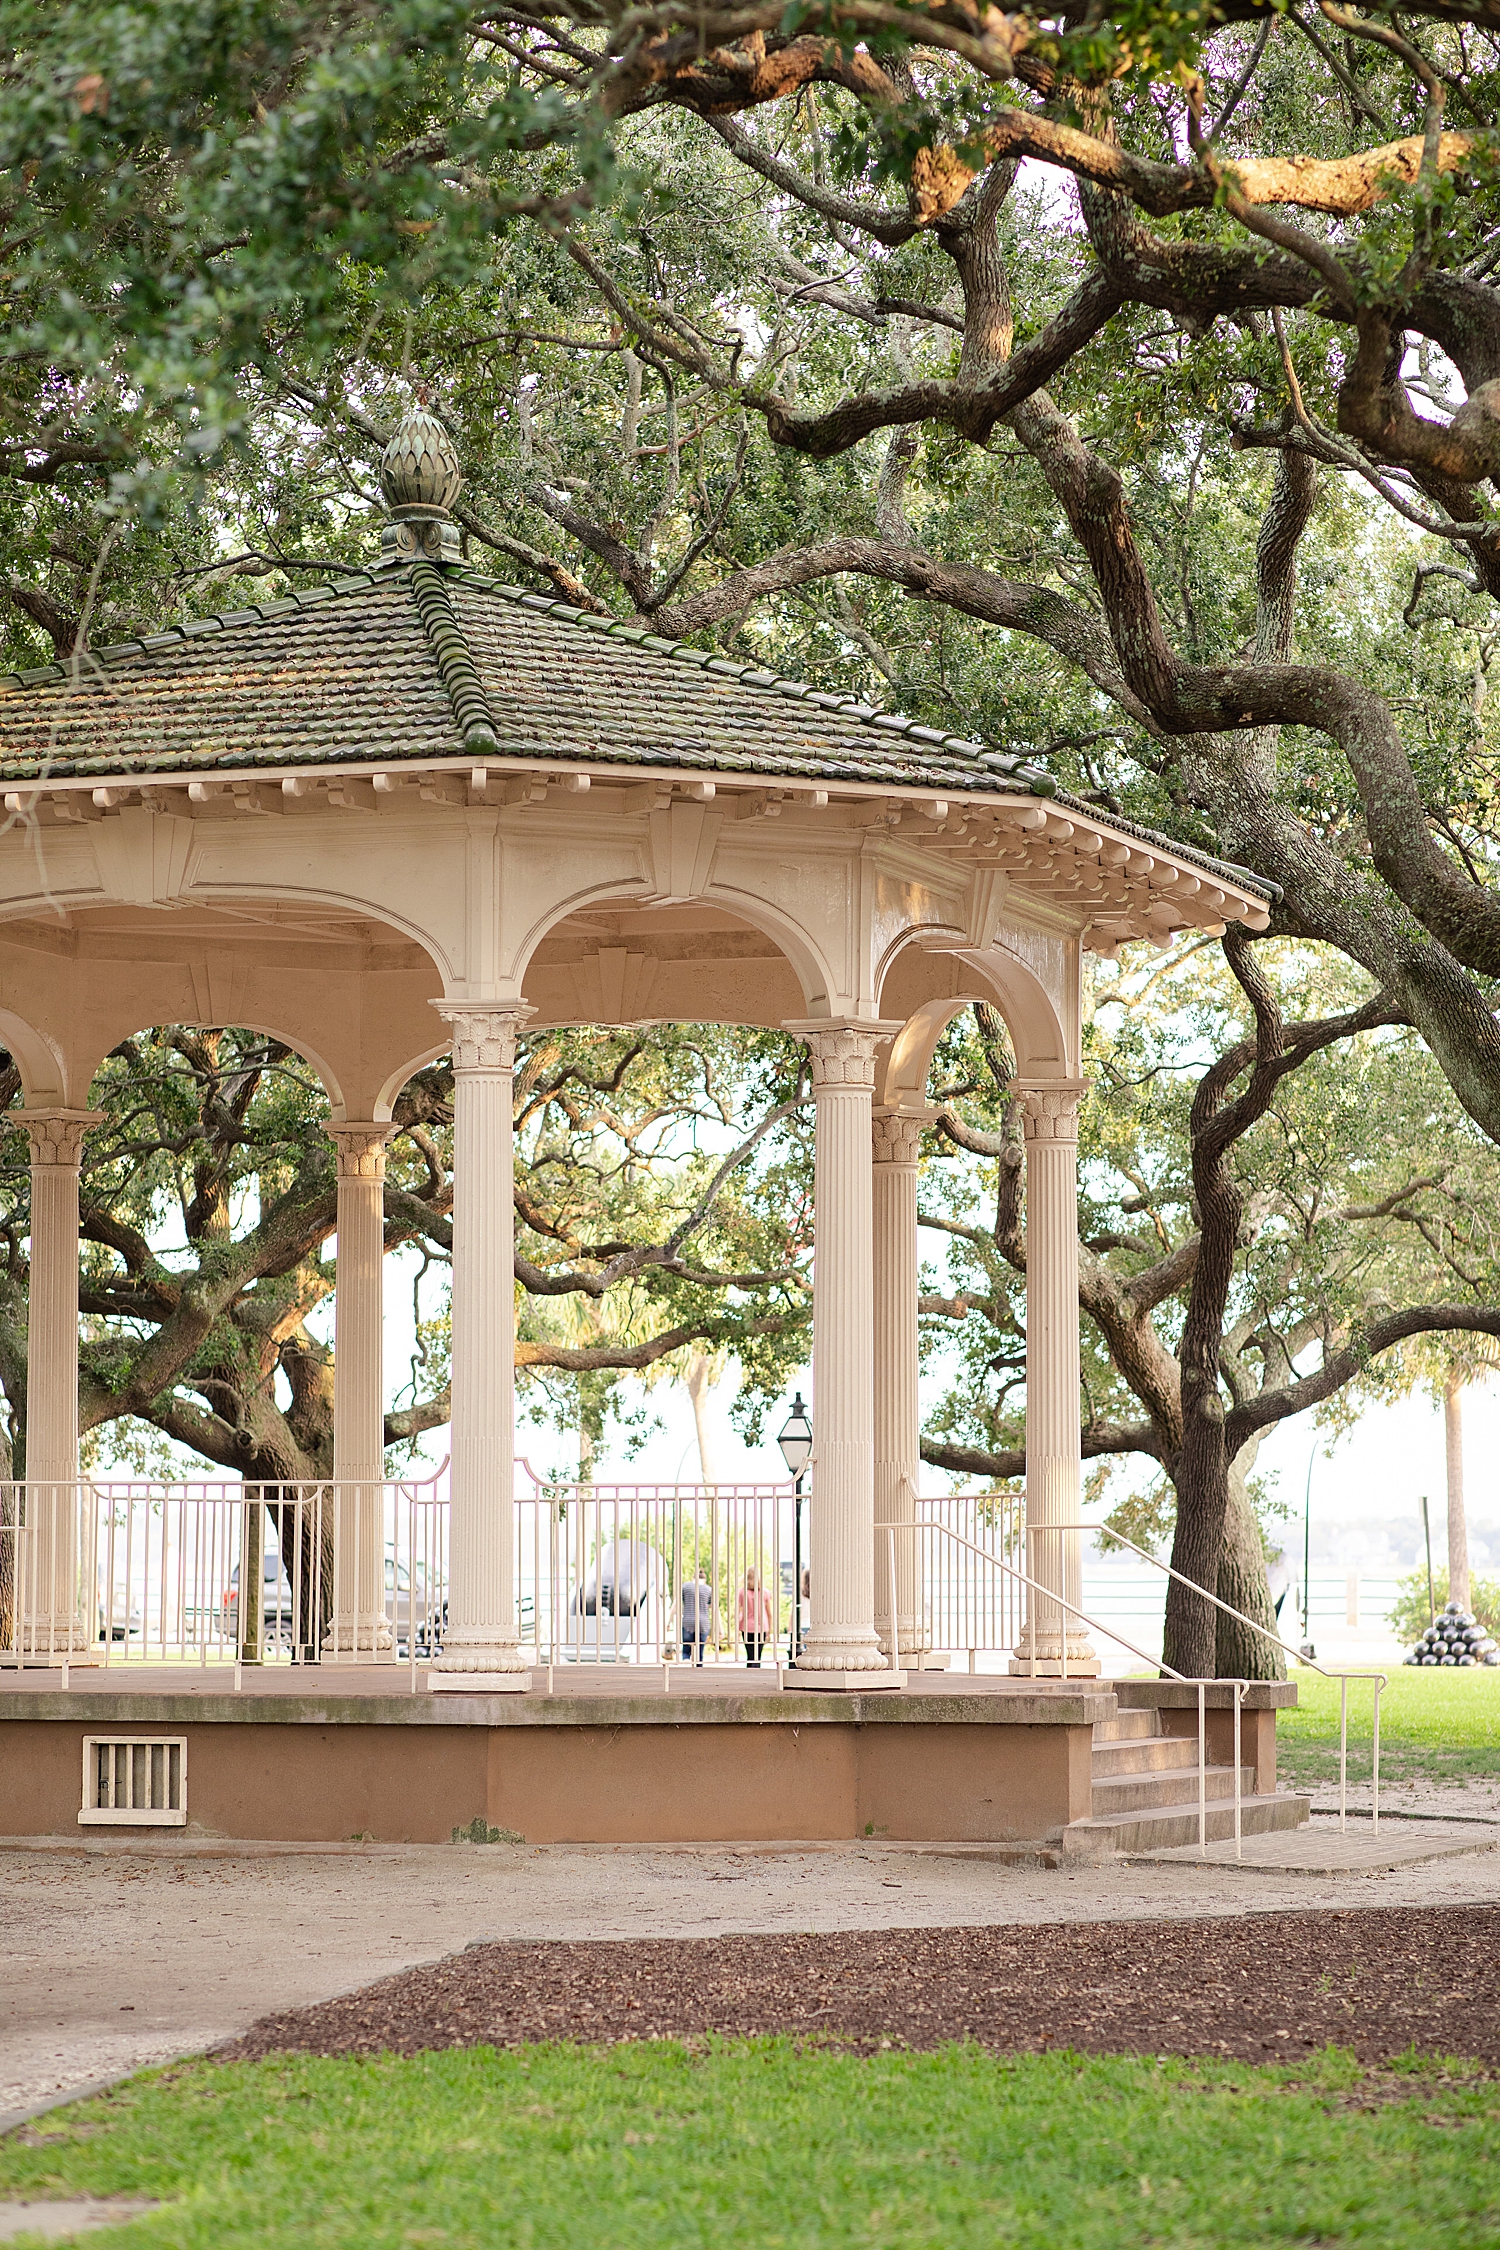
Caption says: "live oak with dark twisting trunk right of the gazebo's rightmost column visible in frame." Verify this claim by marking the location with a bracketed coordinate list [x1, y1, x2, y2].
[920, 936, 1500, 1679]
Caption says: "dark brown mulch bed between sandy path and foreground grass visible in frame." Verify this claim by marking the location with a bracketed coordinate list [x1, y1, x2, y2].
[218, 1906, 1500, 2063]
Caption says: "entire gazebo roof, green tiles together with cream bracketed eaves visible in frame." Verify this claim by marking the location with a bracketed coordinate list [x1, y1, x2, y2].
[0, 492, 1275, 950]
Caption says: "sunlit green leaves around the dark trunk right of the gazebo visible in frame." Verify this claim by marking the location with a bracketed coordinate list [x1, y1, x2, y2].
[920, 943, 1500, 1503]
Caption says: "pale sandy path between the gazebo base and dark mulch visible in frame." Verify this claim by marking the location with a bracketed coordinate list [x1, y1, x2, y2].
[0, 1845, 1500, 2117]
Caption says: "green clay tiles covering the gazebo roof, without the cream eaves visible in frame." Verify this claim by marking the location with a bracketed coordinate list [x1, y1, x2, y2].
[0, 563, 1271, 891]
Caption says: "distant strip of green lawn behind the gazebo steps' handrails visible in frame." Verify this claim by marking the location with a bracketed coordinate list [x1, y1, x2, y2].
[1275, 1665, 1500, 1784]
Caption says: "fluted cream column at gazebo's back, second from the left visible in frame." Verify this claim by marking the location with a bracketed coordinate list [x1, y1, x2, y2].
[324, 1125, 394, 1658]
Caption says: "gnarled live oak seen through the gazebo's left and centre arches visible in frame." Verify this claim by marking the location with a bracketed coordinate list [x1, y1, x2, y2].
[0, 1026, 810, 1483]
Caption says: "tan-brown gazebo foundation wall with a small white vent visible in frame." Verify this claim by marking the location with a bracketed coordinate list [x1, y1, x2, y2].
[0, 1690, 1113, 1845]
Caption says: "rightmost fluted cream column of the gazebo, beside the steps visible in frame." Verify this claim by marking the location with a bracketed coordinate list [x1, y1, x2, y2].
[1010, 1078, 1100, 1676]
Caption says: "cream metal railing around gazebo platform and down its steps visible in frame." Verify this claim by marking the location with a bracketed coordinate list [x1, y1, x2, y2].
[0, 1460, 1388, 1838]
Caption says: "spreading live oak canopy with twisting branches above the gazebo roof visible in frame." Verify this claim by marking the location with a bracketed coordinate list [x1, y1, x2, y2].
[14, 0, 1500, 1670]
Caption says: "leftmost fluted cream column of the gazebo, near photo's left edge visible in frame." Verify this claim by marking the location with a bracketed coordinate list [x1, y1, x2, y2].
[18, 1109, 103, 1663]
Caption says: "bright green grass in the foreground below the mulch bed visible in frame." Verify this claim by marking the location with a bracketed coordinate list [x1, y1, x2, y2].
[0, 2041, 1500, 2250]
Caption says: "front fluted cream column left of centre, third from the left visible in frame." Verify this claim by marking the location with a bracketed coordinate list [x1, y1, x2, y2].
[430, 1001, 533, 1688]
